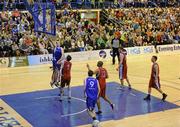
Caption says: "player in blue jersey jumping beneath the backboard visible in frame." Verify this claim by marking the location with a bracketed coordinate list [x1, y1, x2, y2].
[50, 43, 64, 87]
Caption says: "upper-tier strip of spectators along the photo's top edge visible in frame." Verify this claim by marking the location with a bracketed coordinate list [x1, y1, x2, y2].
[0, 0, 180, 10]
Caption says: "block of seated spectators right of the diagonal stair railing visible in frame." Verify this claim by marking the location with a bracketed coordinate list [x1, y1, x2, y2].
[104, 8, 180, 46]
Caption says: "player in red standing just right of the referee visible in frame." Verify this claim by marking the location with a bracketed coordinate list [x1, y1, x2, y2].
[116, 48, 131, 89]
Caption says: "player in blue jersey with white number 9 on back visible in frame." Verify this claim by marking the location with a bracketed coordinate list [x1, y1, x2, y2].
[84, 70, 100, 124]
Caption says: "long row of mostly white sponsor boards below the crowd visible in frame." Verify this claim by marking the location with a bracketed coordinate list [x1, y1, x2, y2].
[0, 44, 180, 67]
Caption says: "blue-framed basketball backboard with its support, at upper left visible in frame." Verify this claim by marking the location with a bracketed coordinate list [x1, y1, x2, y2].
[24, 0, 56, 35]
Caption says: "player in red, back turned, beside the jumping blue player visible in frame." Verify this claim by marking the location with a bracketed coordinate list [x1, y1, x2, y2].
[60, 55, 72, 99]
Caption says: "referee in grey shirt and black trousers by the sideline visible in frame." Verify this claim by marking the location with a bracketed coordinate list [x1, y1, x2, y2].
[111, 36, 120, 65]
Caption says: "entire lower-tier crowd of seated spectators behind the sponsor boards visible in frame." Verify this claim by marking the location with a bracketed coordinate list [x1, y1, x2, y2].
[0, 8, 180, 57]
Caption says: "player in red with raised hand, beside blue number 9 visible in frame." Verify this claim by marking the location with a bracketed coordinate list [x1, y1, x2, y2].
[87, 61, 114, 114]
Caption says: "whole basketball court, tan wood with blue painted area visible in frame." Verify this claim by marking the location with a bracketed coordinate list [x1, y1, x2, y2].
[0, 52, 180, 127]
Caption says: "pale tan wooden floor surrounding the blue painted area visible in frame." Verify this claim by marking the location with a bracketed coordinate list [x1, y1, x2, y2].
[0, 52, 180, 127]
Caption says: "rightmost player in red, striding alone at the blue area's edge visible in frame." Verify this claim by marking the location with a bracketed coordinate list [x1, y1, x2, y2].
[144, 56, 167, 101]
